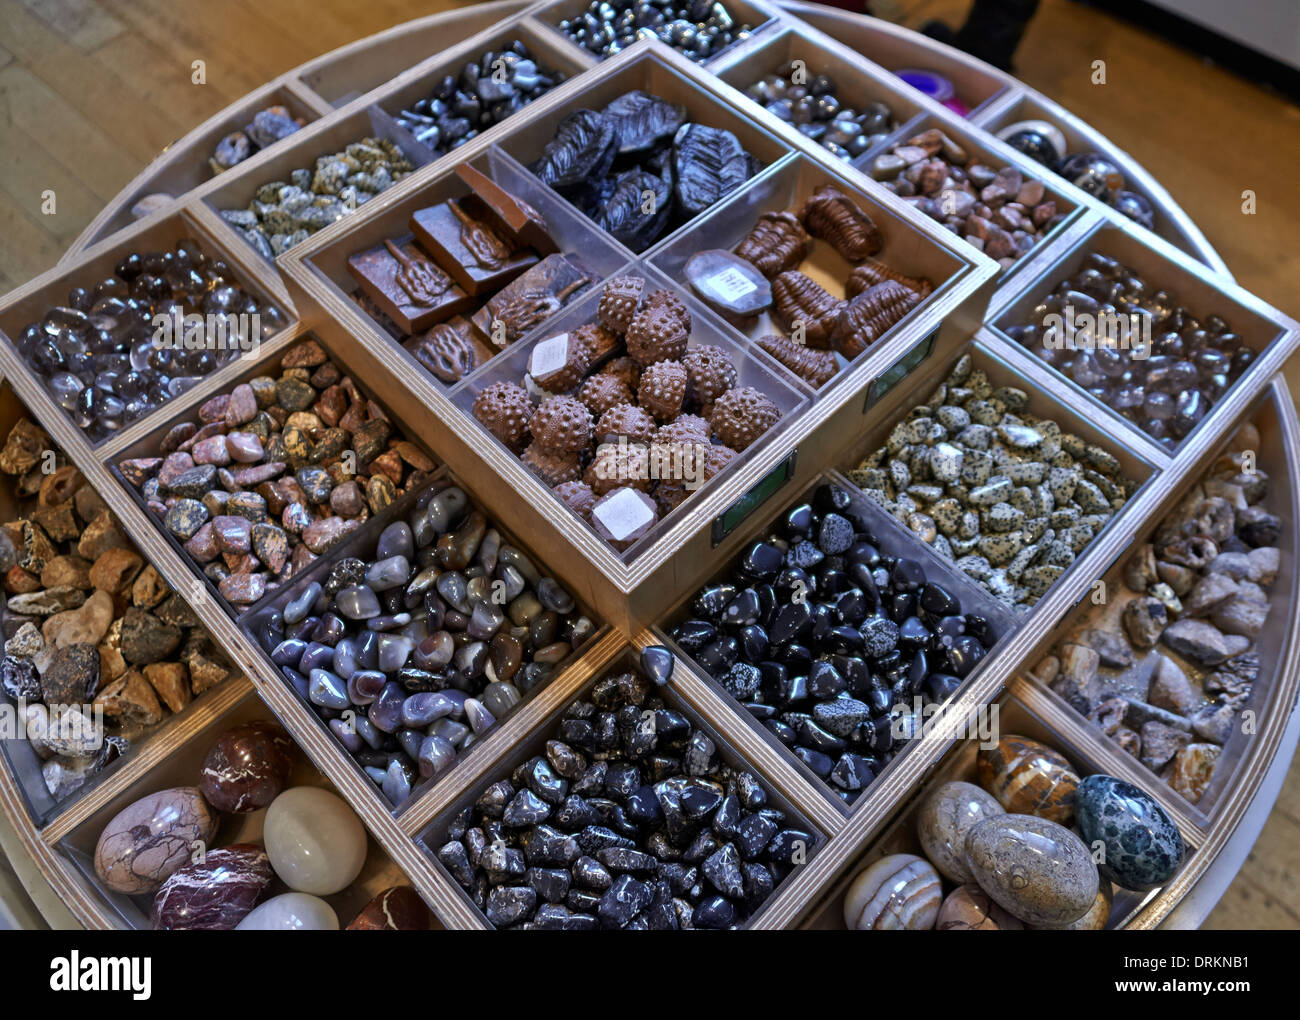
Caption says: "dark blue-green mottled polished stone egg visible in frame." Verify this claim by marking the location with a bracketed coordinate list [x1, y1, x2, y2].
[1075, 776, 1183, 891]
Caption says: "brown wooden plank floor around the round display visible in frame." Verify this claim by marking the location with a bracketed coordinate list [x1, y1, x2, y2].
[0, 0, 1300, 929]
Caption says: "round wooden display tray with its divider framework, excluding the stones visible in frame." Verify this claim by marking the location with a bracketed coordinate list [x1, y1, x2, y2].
[0, 0, 1300, 928]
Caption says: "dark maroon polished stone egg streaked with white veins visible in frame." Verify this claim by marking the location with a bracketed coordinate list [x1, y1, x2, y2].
[152, 843, 274, 932]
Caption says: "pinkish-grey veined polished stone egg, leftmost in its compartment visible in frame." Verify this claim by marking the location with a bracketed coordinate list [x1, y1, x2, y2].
[95, 786, 217, 895]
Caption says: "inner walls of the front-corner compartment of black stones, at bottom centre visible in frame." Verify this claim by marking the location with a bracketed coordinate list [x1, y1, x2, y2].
[417, 648, 827, 928]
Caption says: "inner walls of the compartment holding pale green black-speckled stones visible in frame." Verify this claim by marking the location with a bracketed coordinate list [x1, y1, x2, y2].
[841, 339, 1164, 613]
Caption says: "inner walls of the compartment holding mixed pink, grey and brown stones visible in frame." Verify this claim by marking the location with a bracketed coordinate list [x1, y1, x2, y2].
[109, 334, 438, 620]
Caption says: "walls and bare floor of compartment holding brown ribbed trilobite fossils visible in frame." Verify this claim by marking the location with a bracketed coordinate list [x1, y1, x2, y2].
[646, 153, 970, 389]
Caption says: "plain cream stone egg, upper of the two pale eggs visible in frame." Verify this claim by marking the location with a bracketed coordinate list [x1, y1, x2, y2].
[264, 786, 367, 897]
